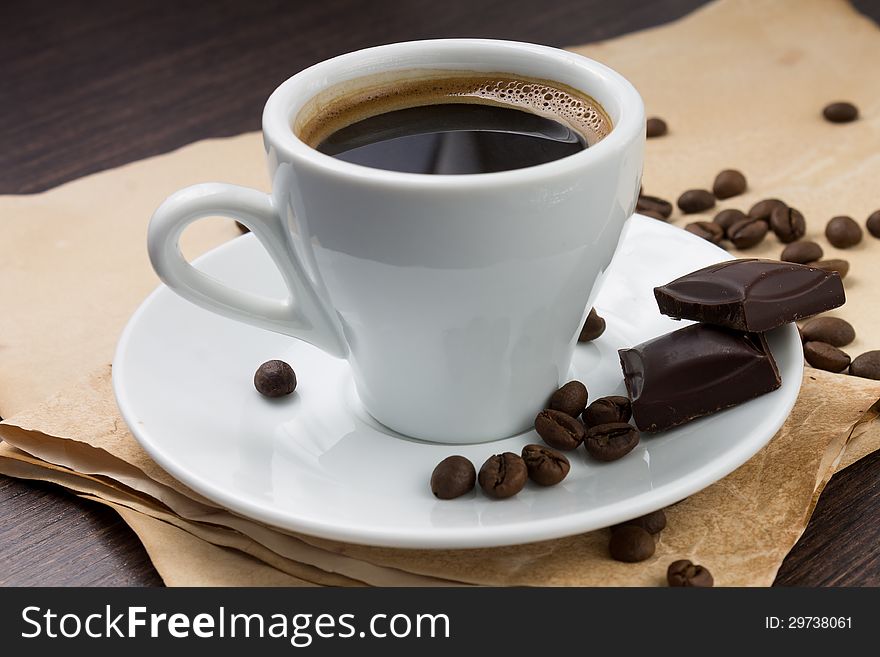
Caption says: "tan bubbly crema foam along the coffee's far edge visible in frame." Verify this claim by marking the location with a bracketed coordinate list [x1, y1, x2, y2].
[293, 72, 612, 148]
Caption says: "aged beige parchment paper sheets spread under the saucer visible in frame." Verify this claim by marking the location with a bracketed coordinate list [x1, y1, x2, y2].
[0, 0, 880, 585]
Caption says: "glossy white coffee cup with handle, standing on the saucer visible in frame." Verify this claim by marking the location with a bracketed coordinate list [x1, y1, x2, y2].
[148, 39, 645, 443]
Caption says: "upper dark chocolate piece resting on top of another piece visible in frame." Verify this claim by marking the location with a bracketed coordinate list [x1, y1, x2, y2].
[654, 259, 846, 332]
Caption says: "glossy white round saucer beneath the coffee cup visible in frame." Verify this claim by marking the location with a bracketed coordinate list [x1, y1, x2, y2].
[113, 216, 803, 548]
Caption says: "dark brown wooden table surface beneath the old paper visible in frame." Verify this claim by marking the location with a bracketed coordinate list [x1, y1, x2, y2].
[0, 0, 880, 585]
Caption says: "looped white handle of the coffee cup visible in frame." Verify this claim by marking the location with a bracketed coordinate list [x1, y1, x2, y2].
[147, 183, 348, 358]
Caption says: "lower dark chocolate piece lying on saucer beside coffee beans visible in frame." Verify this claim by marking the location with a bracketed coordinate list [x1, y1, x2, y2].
[618, 324, 782, 431]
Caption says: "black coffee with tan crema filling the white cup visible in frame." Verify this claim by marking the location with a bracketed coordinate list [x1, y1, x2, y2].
[298, 75, 611, 174]
